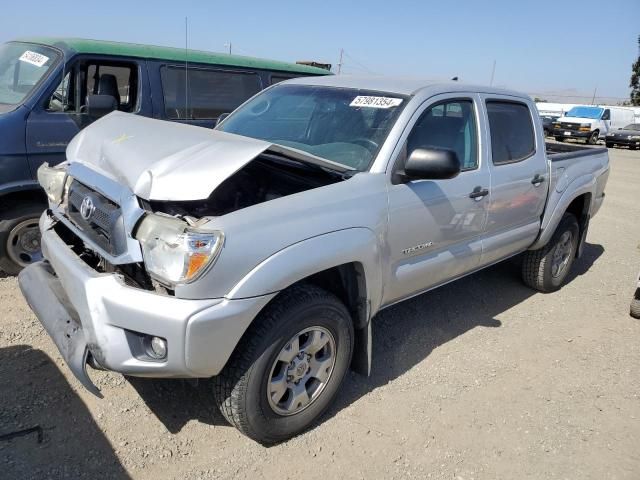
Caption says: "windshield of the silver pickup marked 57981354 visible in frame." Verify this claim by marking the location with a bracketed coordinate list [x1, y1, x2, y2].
[218, 85, 406, 171]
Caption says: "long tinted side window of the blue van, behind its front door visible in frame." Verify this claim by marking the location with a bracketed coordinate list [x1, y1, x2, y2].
[160, 67, 261, 120]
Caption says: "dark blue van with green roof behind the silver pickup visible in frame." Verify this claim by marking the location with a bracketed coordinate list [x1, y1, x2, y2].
[0, 38, 329, 274]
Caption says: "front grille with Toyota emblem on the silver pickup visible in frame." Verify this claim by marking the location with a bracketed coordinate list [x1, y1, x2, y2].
[67, 180, 127, 256]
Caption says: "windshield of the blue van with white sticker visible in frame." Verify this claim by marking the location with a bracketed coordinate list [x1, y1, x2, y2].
[0, 42, 59, 110]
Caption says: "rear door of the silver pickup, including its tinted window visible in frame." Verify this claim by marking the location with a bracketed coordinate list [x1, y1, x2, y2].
[481, 95, 549, 265]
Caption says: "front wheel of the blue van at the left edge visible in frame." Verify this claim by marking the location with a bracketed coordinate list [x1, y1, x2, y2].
[0, 202, 46, 275]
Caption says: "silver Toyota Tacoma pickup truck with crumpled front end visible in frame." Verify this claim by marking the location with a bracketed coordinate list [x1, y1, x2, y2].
[19, 76, 609, 443]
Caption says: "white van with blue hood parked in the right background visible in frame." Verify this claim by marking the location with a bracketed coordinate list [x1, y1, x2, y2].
[553, 106, 635, 145]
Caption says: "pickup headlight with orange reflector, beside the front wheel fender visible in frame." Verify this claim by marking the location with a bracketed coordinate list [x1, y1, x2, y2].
[135, 214, 224, 285]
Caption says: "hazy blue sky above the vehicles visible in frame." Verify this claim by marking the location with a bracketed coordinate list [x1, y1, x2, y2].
[0, 0, 640, 103]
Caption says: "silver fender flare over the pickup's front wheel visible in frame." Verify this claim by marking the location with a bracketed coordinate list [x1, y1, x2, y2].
[226, 227, 382, 319]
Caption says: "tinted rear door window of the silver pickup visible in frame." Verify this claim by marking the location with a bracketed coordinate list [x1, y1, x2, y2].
[487, 100, 536, 165]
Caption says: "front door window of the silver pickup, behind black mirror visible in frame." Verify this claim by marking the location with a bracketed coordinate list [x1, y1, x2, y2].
[407, 100, 478, 170]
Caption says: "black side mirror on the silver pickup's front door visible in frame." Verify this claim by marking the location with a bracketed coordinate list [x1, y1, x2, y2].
[404, 148, 461, 180]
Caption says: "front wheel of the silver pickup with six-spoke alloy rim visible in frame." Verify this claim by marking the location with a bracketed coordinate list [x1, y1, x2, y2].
[214, 285, 354, 444]
